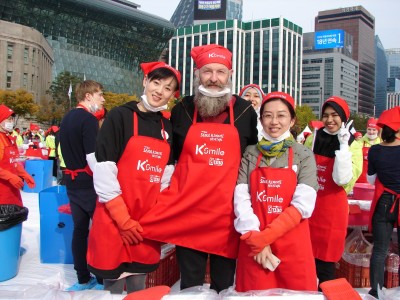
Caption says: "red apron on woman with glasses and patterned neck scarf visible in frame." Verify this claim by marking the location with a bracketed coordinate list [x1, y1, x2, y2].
[235, 148, 317, 292]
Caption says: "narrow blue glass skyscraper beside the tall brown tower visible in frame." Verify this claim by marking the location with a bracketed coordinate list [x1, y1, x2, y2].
[375, 36, 388, 118]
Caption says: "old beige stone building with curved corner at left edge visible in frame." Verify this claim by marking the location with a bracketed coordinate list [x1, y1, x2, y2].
[0, 20, 54, 100]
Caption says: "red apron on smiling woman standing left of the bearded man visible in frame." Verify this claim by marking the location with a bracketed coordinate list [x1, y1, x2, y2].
[87, 113, 170, 270]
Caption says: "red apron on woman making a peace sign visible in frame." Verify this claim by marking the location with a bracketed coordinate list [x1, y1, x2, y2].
[310, 154, 349, 262]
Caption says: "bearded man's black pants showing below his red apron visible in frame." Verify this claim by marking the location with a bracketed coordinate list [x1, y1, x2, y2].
[176, 246, 236, 293]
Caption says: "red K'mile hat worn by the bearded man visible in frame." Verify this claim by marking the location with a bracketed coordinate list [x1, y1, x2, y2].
[190, 44, 232, 70]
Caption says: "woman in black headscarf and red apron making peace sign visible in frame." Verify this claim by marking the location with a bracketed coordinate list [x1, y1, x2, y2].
[305, 96, 362, 283]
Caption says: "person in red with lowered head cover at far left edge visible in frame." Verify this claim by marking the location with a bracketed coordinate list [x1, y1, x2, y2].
[0, 104, 35, 206]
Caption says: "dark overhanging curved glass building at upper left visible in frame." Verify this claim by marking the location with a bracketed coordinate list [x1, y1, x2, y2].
[0, 0, 175, 94]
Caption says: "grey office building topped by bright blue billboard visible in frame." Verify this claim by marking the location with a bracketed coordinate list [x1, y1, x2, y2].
[301, 31, 359, 118]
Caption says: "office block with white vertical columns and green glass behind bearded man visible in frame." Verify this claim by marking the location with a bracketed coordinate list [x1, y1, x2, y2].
[169, 17, 303, 103]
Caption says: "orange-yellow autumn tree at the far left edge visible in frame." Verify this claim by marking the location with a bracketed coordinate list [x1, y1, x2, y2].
[0, 89, 39, 120]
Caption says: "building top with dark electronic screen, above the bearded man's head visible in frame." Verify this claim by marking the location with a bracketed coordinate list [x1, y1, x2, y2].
[171, 0, 243, 28]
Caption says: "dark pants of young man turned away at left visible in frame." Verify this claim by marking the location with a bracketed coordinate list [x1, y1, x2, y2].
[67, 188, 103, 284]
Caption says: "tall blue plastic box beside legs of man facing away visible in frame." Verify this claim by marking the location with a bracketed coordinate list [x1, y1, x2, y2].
[39, 185, 74, 264]
